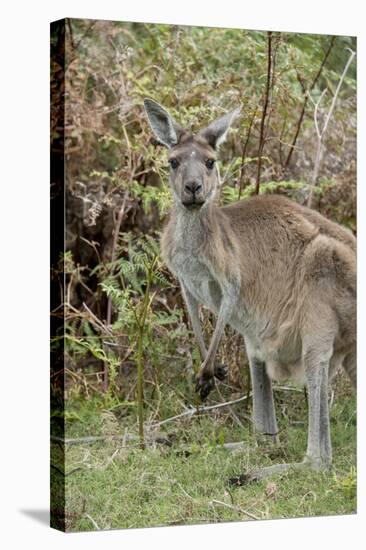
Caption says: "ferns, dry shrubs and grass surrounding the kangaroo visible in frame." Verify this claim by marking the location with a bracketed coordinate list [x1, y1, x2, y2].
[51, 19, 356, 530]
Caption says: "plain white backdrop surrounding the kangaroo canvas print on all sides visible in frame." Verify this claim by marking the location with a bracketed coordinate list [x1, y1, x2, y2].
[0, 0, 366, 550]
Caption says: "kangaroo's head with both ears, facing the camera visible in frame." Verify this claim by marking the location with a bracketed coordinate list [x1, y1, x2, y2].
[144, 99, 240, 210]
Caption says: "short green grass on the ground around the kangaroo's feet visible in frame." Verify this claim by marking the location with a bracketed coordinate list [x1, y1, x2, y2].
[52, 376, 356, 531]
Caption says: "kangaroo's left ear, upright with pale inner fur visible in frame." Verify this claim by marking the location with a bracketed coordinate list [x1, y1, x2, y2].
[144, 99, 183, 149]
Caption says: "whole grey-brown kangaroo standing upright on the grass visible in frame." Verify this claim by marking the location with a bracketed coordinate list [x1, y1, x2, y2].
[144, 99, 356, 479]
